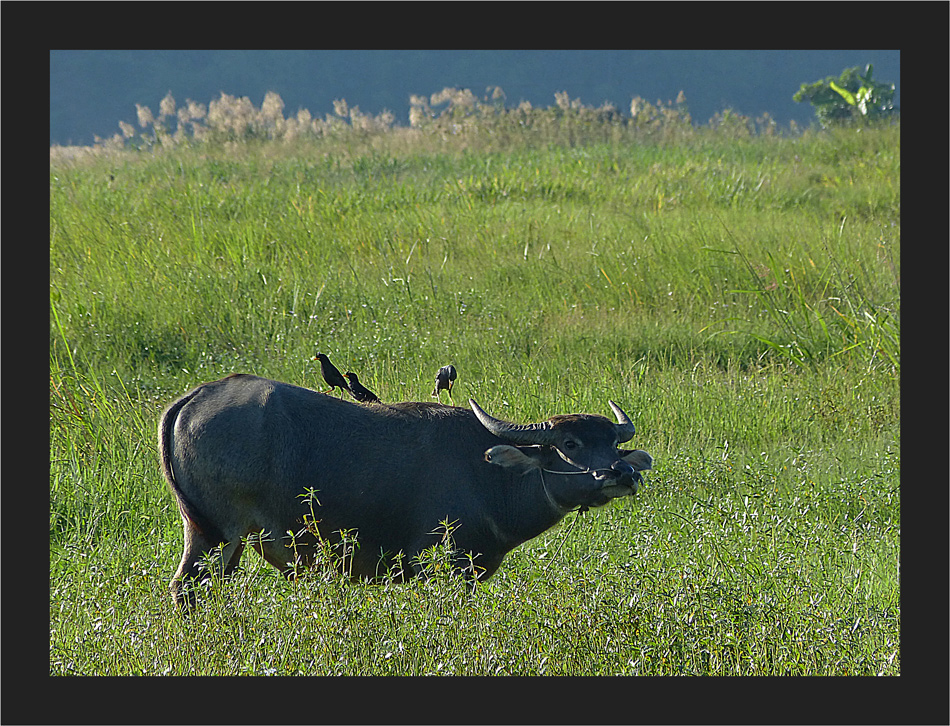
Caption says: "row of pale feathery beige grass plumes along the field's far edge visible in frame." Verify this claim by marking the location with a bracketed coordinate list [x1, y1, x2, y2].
[57, 87, 796, 166]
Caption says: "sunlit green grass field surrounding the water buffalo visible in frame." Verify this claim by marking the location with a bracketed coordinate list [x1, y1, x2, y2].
[49, 98, 901, 676]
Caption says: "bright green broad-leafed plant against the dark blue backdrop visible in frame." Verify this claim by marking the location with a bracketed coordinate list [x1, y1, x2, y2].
[792, 63, 899, 127]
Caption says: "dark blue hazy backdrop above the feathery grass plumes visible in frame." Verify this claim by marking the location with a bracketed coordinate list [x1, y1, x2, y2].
[50, 50, 900, 145]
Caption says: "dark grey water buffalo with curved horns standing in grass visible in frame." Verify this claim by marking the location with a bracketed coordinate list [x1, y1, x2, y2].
[159, 374, 653, 603]
